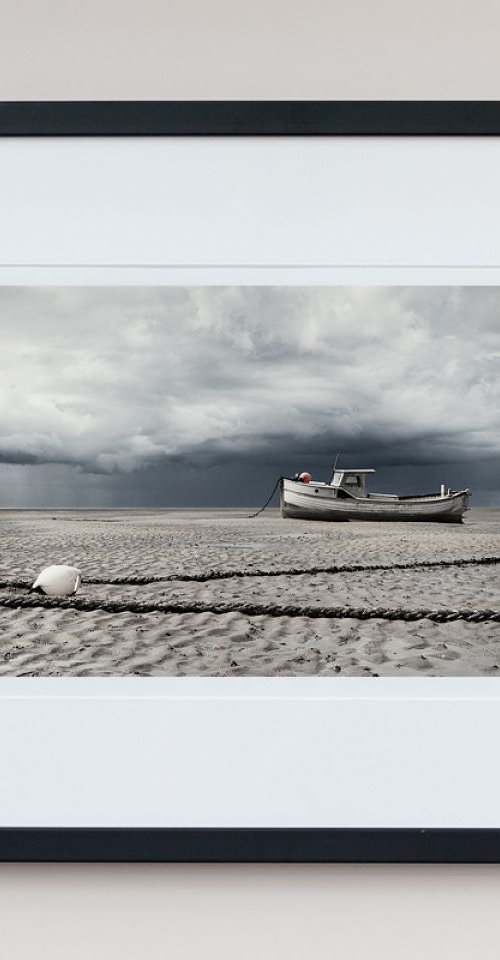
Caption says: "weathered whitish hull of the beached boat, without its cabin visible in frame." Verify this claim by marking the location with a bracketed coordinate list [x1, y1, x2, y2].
[280, 479, 469, 523]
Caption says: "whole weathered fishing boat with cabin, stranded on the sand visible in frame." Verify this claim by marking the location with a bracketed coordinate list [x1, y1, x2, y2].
[280, 468, 470, 523]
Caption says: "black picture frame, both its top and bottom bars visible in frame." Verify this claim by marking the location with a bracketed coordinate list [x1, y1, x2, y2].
[0, 101, 500, 863]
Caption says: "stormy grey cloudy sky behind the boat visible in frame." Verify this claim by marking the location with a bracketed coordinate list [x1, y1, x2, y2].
[0, 286, 500, 508]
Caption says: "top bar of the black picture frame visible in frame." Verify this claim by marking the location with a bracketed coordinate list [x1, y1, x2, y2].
[0, 100, 500, 137]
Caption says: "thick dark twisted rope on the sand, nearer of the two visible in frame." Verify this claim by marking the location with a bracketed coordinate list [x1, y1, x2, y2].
[0, 594, 500, 623]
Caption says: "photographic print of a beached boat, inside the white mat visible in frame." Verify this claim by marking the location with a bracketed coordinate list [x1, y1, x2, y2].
[0, 286, 500, 678]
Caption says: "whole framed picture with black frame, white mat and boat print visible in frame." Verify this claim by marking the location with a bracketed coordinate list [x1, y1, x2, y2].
[0, 102, 500, 862]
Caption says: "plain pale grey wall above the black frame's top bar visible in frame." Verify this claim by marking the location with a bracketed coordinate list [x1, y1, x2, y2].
[0, 0, 500, 100]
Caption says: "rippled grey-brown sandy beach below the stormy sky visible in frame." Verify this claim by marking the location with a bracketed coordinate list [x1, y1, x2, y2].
[0, 508, 500, 677]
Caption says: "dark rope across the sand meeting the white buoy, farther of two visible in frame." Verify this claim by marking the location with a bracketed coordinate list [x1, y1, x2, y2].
[0, 557, 500, 590]
